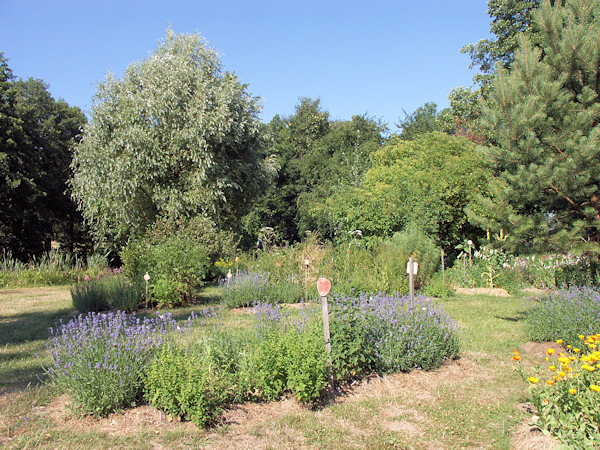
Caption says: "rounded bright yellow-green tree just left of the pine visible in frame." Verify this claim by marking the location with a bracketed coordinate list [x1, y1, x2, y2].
[323, 132, 491, 249]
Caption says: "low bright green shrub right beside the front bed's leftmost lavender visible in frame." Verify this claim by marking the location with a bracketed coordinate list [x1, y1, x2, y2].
[144, 344, 233, 427]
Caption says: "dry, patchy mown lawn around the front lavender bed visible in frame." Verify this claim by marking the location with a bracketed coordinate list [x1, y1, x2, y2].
[0, 286, 552, 449]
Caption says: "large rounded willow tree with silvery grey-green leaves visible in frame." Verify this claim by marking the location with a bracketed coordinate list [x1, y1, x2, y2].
[71, 29, 266, 250]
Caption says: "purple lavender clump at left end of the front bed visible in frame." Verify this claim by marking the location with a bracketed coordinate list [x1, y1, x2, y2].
[47, 311, 197, 416]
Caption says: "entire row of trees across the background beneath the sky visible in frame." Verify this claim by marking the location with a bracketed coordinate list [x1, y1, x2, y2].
[0, 0, 600, 257]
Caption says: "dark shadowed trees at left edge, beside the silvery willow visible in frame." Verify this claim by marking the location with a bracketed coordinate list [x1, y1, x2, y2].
[0, 54, 86, 259]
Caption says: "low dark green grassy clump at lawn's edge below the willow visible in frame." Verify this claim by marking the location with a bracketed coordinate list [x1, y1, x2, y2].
[71, 275, 142, 313]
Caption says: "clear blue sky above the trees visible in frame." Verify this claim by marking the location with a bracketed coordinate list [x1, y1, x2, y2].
[0, 0, 490, 129]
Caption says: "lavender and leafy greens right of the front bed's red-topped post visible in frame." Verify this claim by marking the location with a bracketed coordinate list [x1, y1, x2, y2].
[331, 294, 458, 378]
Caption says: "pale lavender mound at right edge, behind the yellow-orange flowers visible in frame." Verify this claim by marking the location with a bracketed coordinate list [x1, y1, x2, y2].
[527, 286, 600, 345]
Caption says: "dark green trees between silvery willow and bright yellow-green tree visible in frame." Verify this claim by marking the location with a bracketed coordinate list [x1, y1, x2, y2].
[244, 98, 385, 246]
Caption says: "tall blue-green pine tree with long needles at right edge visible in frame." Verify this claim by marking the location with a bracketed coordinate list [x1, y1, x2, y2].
[476, 0, 600, 254]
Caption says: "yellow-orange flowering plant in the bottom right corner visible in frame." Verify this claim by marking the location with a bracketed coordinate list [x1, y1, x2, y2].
[513, 334, 600, 448]
